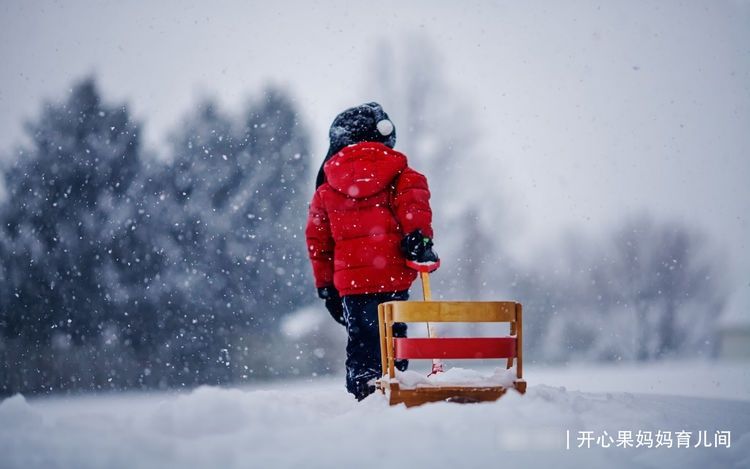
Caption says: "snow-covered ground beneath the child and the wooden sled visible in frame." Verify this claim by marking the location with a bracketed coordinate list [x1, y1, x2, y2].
[0, 362, 750, 468]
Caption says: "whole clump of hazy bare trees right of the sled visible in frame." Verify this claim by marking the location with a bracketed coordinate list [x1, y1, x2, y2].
[513, 213, 723, 361]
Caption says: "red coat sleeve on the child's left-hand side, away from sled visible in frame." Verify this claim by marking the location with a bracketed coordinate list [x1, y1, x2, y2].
[305, 188, 334, 288]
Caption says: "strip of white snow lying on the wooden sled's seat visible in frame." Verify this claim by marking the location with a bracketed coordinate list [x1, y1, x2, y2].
[383, 367, 516, 389]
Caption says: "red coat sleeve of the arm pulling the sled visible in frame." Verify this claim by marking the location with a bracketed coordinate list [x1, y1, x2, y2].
[393, 168, 433, 238]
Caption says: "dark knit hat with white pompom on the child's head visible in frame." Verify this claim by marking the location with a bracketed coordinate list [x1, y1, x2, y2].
[315, 102, 396, 187]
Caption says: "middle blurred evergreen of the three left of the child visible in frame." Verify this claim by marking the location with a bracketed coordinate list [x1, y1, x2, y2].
[135, 100, 246, 385]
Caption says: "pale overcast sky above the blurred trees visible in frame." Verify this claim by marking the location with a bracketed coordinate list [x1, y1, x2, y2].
[0, 0, 750, 314]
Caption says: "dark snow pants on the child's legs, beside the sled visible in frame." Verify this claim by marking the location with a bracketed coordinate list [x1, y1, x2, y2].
[342, 290, 409, 401]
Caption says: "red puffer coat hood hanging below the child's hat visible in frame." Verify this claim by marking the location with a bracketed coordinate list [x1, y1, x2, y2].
[323, 142, 407, 199]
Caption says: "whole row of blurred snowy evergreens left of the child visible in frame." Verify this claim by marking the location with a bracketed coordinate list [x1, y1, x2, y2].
[0, 79, 314, 393]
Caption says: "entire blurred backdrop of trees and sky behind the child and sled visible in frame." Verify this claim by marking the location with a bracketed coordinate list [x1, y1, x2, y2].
[0, 0, 750, 395]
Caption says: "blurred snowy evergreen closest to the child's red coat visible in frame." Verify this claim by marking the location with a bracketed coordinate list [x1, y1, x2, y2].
[241, 88, 311, 330]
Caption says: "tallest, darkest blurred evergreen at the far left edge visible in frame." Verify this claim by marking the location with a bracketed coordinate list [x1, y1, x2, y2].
[0, 79, 145, 394]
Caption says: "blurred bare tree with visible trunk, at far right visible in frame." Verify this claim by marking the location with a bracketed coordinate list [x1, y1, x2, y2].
[592, 214, 723, 360]
